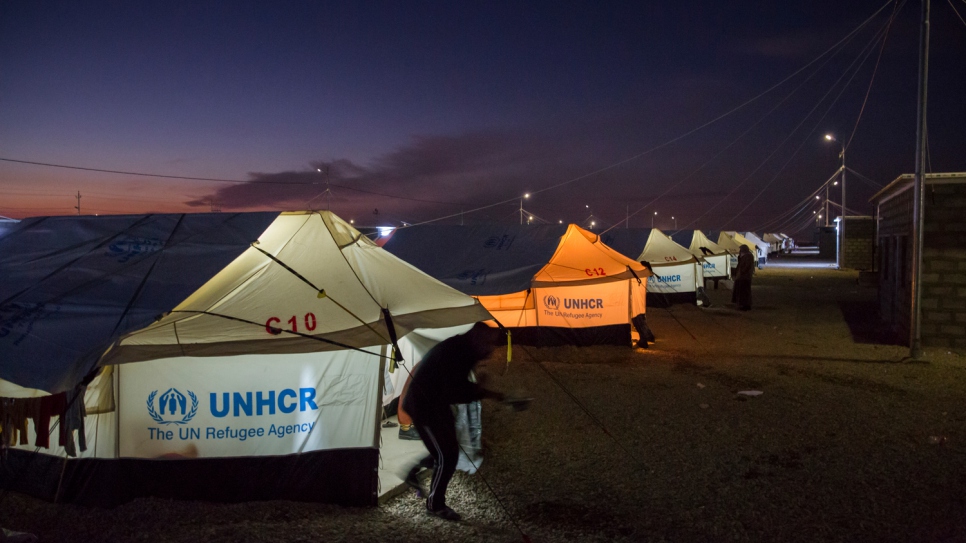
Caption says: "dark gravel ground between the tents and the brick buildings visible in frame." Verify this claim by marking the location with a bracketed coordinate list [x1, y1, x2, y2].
[0, 252, 966, 542]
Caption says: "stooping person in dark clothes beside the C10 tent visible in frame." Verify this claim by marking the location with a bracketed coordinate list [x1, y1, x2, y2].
[403, 322, 504, 520]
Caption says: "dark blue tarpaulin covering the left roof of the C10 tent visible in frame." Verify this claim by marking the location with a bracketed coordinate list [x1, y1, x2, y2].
[0, 212, 278, 393]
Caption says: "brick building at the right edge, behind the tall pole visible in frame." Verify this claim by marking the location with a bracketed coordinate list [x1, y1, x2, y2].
[872, 173, 966, 348]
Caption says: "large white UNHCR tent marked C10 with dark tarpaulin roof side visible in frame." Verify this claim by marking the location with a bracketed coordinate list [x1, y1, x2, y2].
[0, 212, 490, 505]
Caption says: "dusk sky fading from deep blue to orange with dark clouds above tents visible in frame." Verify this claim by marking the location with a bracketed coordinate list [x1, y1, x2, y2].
[0, 0, 966, 236]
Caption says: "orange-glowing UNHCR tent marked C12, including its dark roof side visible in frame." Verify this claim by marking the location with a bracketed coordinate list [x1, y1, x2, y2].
[384, 224, 653, 346]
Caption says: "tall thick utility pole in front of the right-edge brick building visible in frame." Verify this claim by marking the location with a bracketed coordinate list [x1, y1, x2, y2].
[916, 0, 929, 359]
